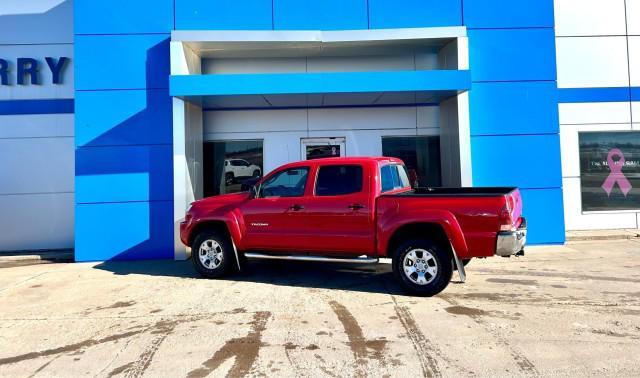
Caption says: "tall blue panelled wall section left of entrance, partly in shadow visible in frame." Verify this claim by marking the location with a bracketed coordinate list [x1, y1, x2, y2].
[74, 0, 174, 261]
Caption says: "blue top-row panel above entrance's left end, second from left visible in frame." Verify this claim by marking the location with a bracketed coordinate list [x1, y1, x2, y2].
[176, 0, 273, 30]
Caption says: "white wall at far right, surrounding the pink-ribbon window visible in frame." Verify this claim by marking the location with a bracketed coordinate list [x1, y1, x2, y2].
[555, 0, 640, 230]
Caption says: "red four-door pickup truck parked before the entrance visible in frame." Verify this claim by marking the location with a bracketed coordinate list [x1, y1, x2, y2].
[180, 157, 527, 296]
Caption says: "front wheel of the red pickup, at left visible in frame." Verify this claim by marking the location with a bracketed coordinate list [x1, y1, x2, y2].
[191, 230, 236, 278]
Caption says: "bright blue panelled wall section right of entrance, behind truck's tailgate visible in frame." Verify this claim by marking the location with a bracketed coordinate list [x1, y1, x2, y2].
[463, 0, 565, 244]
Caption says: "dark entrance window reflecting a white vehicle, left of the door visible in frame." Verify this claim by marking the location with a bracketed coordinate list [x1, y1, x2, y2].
[205, 140, 263, 197]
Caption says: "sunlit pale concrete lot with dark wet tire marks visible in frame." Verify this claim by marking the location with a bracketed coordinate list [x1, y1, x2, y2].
[0, 240, 640, 377]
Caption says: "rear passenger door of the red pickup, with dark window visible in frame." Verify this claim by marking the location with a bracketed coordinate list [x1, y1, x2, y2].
[304, 164, 375, 255]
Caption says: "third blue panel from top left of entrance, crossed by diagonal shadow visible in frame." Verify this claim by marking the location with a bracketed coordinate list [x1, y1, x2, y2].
[75, 89, 173, 146]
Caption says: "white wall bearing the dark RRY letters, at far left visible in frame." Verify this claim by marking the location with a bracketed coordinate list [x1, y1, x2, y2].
[0, 0, 75, 251]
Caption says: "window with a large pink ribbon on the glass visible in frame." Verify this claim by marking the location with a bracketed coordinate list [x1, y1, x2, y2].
[578, 131, 640, 211]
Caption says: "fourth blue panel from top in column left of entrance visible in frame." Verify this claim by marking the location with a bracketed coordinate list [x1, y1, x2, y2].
[76, 145, 173, 203]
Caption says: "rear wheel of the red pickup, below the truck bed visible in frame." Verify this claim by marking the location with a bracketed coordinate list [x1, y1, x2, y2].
[393, 239, 453, 297]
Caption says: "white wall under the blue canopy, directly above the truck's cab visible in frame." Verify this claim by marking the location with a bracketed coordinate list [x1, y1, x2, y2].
[204, 106, 440, 173]
